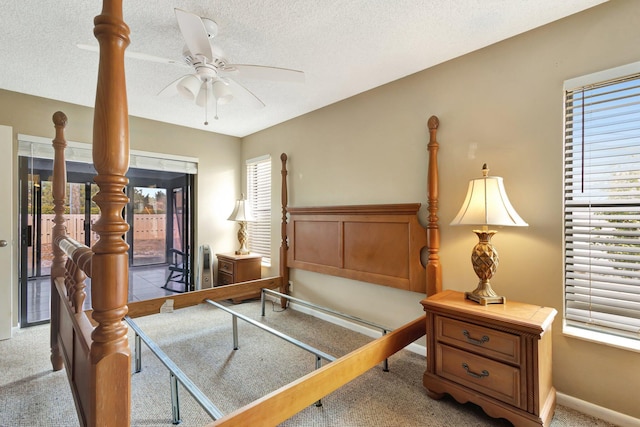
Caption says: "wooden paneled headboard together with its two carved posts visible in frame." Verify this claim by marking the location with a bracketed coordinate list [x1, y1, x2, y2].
[281, 116, 442, 295]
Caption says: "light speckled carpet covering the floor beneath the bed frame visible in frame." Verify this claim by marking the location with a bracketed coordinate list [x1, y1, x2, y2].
[0, 302, 611, 427]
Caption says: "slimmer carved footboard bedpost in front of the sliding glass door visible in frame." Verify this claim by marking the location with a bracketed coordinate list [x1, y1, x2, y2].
[50, 111, 67, 371]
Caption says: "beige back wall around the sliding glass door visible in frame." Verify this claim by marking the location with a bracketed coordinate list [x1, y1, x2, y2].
[0, 90, 242, 325]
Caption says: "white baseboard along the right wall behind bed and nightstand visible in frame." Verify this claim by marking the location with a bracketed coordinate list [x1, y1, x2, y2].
[282, 302, 640, 427]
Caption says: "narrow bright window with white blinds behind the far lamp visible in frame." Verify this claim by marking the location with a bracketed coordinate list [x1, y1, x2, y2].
[247, 156, 271, 266]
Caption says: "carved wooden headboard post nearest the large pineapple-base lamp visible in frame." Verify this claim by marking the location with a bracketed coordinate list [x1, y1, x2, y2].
[427, 116, 442, 296]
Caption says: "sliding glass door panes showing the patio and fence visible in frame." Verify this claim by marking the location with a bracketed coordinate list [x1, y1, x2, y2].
[19, 156, 194, 326]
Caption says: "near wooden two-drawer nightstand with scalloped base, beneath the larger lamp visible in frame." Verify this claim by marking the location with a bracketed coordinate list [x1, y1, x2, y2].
[422, 291, 556, 426]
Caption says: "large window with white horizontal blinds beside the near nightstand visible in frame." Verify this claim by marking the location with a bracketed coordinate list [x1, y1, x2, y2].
[564, 63, 640, 348]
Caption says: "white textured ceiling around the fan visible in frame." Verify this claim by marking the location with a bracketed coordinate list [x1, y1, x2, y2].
[0, 0, 605, 137]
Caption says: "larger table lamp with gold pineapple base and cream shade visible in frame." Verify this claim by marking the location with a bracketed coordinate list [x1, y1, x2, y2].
[451, 164, 528, 305]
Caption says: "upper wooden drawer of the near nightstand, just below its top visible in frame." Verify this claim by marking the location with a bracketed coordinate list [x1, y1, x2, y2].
[436, 316, 520, 365]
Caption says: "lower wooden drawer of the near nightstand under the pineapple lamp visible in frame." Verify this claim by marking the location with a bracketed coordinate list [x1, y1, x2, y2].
[436, 344, 523, 408]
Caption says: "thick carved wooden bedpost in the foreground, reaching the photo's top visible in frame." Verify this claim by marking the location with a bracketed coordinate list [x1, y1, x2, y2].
[89, 0, 131, 426]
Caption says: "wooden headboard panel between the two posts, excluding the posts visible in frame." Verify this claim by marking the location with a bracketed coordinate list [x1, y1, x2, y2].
[287, 203, 427, 293]
